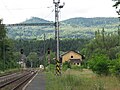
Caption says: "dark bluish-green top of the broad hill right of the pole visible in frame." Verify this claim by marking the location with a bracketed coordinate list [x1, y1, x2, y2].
[62, 17, 119, 27]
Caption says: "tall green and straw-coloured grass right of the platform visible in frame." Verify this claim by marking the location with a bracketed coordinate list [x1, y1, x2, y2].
[46, 69, 120, 90]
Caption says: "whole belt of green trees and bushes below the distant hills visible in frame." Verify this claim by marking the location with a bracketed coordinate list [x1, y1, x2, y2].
[0, 16, 120, 75]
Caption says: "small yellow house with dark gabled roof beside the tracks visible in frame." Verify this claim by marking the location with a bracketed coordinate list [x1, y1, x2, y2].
[61, 51, 83, 65]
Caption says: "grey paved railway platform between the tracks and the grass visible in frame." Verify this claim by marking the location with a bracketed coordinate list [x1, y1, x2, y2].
[23, 71, 45, 90]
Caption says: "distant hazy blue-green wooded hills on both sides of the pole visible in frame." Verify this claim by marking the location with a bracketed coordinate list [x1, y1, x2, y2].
[7, 17, 119, 39]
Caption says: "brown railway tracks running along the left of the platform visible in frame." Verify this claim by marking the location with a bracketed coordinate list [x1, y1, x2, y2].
[0, 71, 37, 90]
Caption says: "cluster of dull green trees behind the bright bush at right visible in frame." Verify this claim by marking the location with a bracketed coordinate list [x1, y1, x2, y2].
[84, 29, 120, 60]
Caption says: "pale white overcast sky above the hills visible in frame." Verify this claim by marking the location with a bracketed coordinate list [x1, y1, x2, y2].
[0, 0, 118, 24]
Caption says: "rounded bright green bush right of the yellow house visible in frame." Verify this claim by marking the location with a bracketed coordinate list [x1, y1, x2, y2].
[88, 55, 109, 75]
